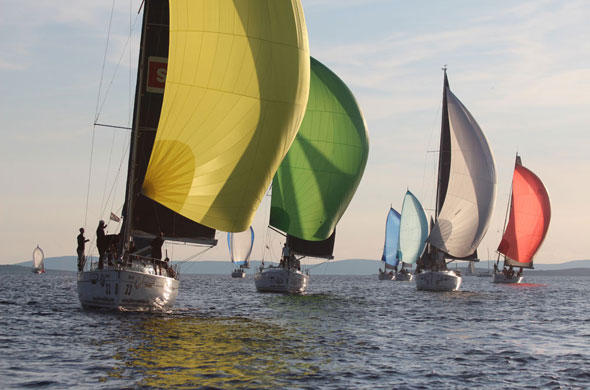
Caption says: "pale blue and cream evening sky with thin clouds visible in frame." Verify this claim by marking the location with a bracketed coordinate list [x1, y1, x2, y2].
[0, 0, 590, 267]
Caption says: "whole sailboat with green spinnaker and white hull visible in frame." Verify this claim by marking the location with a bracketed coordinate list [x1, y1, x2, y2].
[255, 58, 369, 293]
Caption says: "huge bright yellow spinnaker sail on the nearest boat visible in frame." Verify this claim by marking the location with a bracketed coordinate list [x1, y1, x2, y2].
[143, 0, 310, 232]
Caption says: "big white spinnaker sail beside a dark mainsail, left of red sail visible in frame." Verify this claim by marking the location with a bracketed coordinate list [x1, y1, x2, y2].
[429, 89, 496, 257]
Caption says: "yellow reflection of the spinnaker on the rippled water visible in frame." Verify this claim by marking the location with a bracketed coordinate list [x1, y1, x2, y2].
[111, 317, 321, 388]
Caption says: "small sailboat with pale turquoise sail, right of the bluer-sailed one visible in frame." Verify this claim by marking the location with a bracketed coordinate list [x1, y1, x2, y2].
[395, 190, 428, 282]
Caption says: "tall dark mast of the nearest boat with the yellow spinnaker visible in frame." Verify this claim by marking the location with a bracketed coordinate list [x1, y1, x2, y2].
[122, 1, 150, 249]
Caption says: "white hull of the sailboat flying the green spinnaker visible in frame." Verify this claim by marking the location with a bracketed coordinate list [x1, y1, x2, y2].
[254, 267, 309, 294]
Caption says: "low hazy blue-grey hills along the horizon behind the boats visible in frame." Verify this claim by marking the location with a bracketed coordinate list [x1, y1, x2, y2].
[6, 256, 590, 275]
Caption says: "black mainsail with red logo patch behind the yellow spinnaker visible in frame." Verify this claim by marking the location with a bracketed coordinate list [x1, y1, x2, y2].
[122, 0, 217, 245]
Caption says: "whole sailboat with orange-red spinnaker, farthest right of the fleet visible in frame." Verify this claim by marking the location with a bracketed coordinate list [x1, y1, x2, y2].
[492, 154, 551, 283]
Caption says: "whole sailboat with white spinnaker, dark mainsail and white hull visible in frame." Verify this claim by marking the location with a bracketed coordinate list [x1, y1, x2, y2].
[416, 68, 496, 291]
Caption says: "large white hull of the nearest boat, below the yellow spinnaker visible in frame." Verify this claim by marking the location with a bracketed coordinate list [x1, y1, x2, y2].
[78, 268, 179, 311]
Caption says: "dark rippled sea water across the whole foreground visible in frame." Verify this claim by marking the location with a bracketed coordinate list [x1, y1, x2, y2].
[0, 267, 590, 389]
